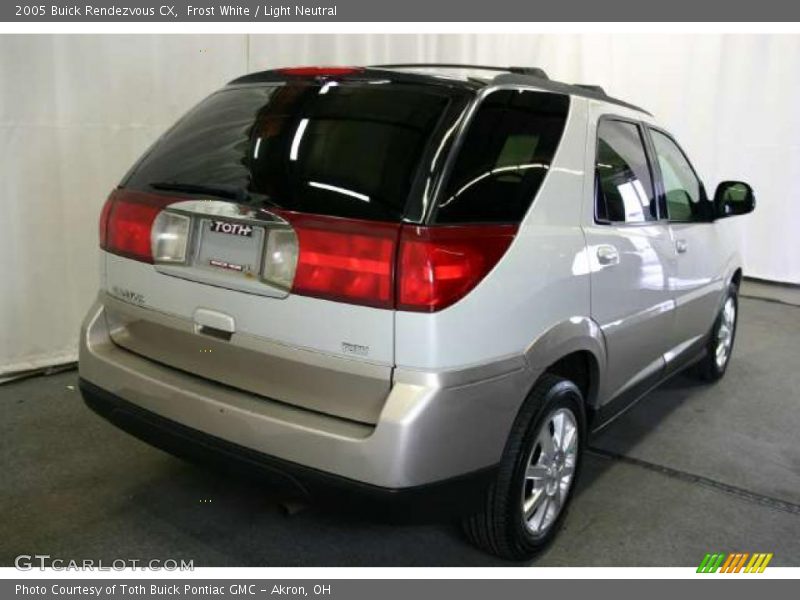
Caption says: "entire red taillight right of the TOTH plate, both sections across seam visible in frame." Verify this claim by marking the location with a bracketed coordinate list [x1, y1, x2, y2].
[281, 212, 517, 312]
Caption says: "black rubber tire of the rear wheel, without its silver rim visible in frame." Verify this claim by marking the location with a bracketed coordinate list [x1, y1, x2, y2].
[463, 373, 586, 560]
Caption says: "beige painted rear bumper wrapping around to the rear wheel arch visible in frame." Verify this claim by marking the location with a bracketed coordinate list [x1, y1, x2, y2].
[79, 302, 532, 496]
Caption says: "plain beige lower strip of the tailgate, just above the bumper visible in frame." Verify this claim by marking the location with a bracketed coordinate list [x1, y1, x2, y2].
[104, 280, 391, 424]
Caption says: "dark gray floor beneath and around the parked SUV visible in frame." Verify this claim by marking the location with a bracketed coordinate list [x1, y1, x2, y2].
[0, 298, 800, 566]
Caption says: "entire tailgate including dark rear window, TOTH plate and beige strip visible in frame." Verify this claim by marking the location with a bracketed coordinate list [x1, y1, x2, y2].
[100, 78, 467, 423]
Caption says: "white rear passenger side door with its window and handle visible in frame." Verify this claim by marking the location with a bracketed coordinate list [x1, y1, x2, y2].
[585, 117, 675, 408]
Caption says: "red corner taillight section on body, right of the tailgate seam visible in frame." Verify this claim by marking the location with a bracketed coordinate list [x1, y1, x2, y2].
[397, 225, 517, 312]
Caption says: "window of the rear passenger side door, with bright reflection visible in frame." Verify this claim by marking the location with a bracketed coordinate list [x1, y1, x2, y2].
[595, 120, 658, 223]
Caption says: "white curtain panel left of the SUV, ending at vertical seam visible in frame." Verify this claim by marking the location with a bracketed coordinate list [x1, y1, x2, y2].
[0, 35, 247, 375]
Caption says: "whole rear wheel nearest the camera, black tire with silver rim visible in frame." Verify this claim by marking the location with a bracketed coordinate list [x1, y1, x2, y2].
[464, 374, 586, 560]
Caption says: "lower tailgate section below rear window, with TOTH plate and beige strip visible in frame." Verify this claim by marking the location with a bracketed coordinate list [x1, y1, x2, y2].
[105, 196, 399, 424]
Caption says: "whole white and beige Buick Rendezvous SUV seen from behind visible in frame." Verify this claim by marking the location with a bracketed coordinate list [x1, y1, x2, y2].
[80, 65, 754, 558]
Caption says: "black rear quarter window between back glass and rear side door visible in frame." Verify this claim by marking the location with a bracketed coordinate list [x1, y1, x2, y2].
[435, 90, 569, 223]
